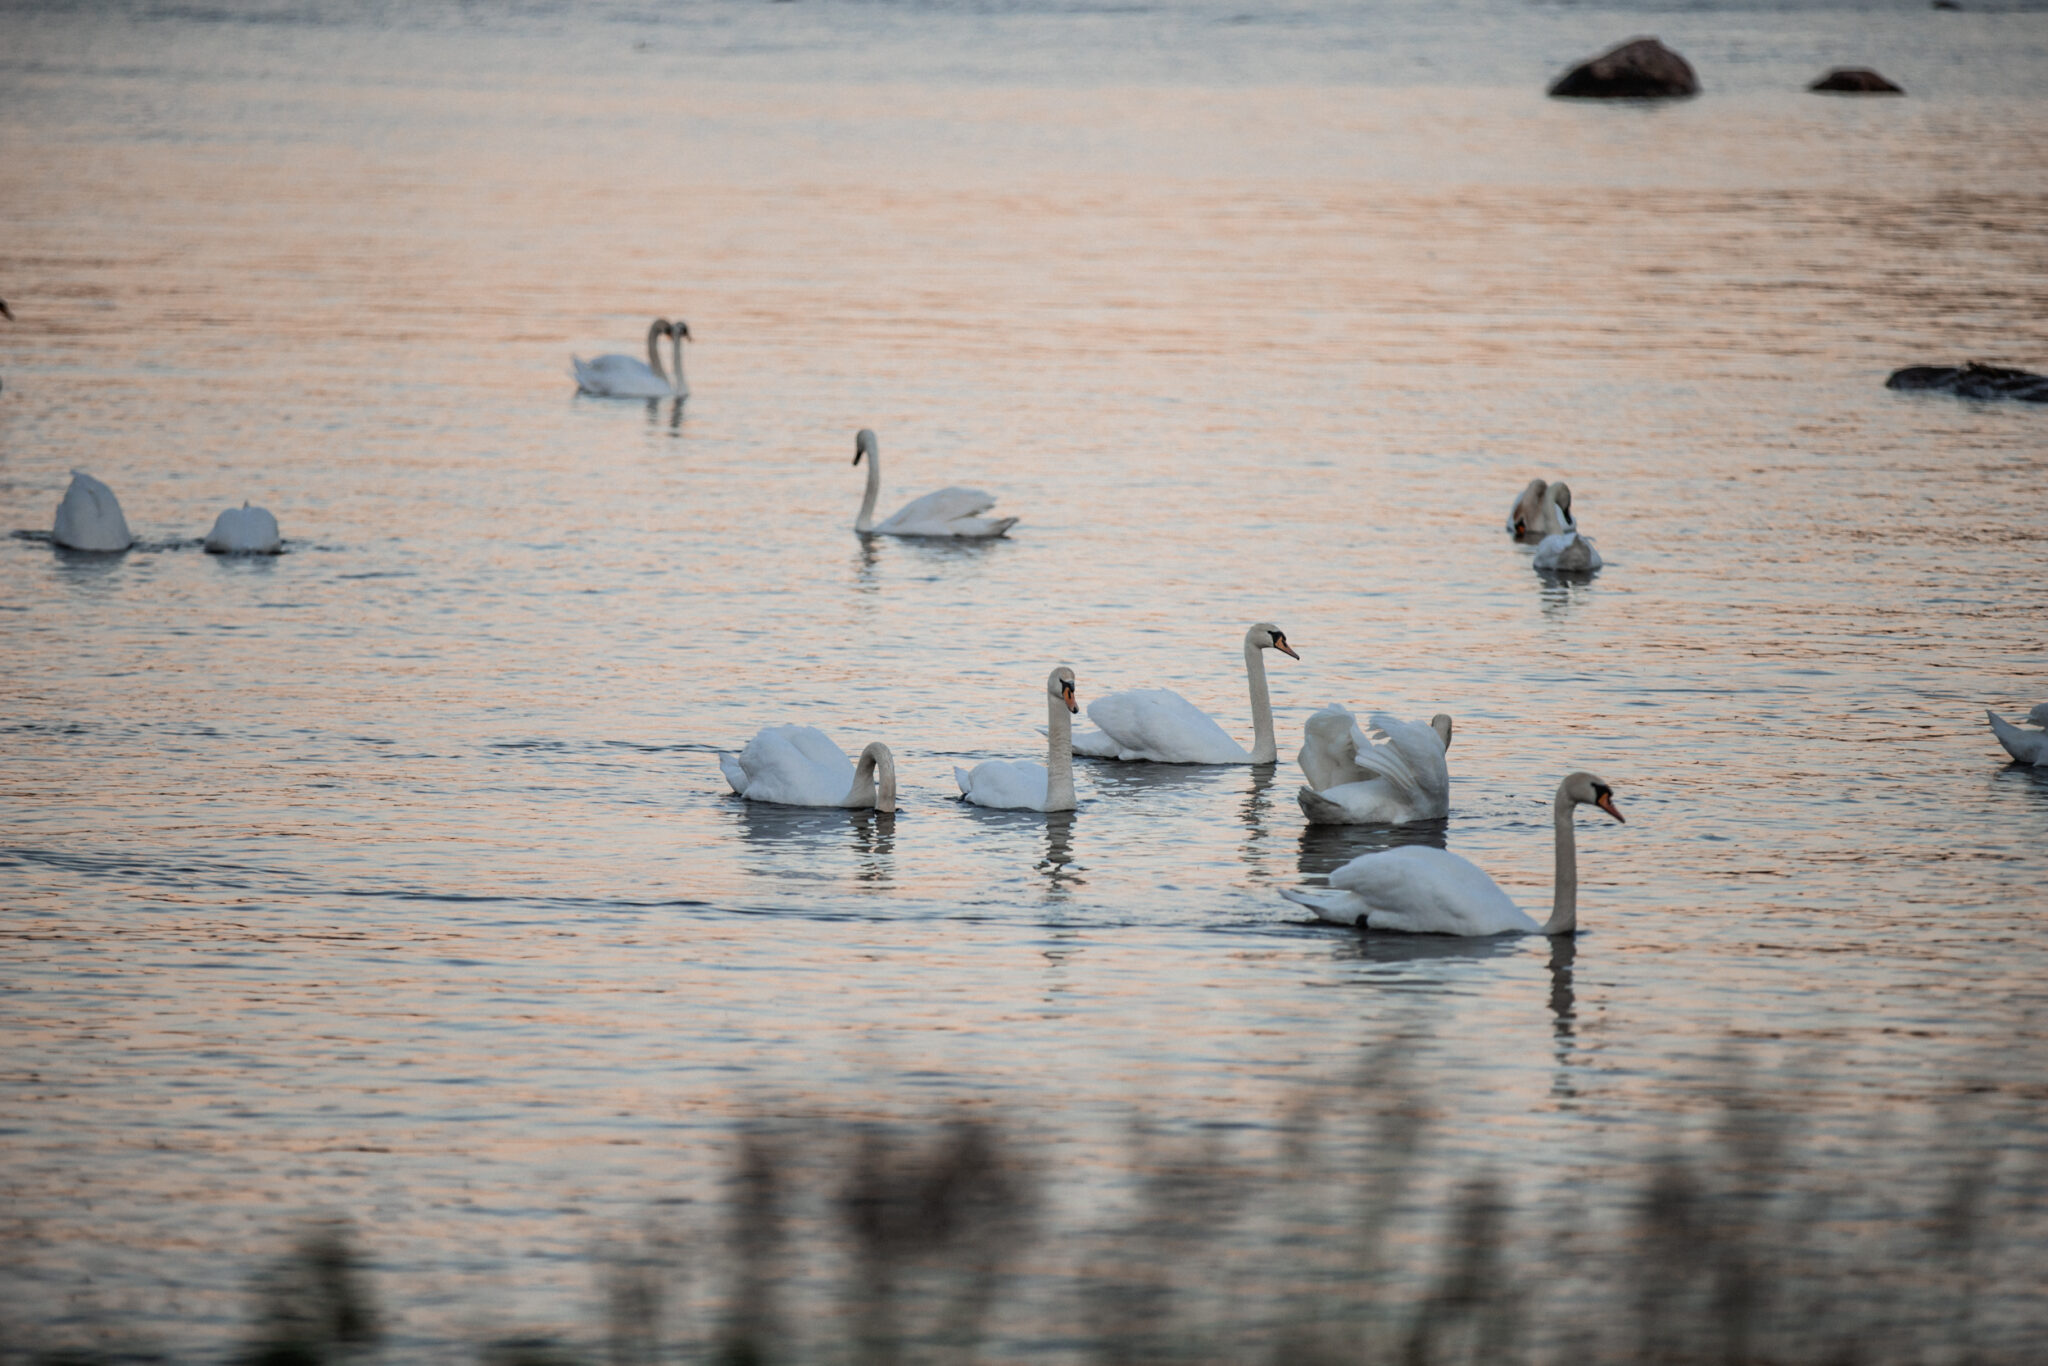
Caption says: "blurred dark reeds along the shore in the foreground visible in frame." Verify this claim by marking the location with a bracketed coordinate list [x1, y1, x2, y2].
[0, 1067, 2048, 1366]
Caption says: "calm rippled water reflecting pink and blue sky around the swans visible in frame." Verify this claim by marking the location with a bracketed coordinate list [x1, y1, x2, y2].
[0, 0, 2048, 1356]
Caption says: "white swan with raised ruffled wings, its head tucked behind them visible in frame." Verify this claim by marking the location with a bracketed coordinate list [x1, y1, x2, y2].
[1294, 705, 1450, 825]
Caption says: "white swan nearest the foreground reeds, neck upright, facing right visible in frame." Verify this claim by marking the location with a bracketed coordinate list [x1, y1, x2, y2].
[1280, 772, 1622, 936]
